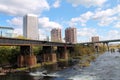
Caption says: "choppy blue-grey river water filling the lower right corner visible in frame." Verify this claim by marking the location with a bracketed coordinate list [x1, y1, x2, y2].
[54, 52, 120, 80]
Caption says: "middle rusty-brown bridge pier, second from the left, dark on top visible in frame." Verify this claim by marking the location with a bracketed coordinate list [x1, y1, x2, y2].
[43, 46, 57, 62]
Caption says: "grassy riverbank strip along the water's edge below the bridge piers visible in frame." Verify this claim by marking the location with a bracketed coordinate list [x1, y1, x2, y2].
[0, 51, 104, 75]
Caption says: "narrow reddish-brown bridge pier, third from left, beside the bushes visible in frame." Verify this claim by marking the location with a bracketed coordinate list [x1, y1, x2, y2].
[57, 46, 68, 60]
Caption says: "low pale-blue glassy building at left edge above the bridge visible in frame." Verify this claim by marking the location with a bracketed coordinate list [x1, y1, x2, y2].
[0, 26, 14, 37]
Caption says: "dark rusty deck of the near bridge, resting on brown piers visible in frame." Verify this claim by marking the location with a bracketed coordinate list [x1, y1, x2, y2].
[0, 37, 72, 46]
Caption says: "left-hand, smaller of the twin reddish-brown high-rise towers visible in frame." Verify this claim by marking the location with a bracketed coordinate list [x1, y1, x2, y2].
[51, 29, 62, 42]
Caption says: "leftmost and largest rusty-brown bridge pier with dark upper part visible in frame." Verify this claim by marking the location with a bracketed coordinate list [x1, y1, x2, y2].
[18, 46, 37, 67]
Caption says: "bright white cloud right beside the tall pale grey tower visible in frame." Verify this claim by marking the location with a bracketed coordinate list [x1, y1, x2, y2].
[39, 17, 62, 29]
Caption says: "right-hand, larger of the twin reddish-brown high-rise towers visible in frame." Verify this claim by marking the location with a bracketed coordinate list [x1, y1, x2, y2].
[65, 27, 77, 43]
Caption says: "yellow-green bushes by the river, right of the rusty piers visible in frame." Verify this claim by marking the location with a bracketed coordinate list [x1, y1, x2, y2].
[72, 45, 106, 68]
